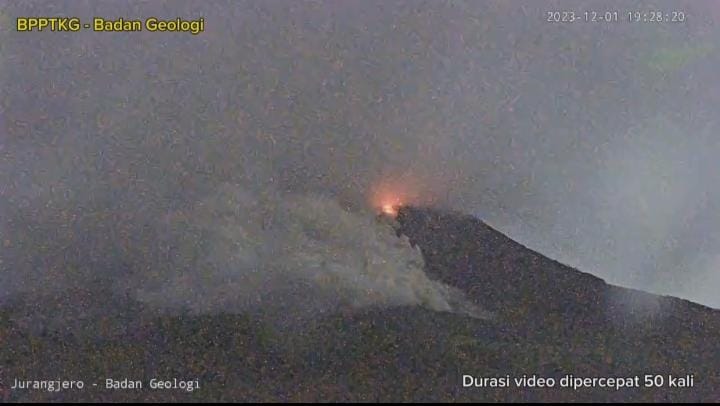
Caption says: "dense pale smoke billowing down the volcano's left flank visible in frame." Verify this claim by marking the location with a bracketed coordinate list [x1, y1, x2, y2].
[131, 184, 486, 316]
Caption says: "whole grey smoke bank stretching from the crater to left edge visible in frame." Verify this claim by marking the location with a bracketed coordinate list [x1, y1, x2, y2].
[0, 178, 491, 324]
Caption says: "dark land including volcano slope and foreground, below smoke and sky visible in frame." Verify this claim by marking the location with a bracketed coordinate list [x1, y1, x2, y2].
[0, 208, 720, 401]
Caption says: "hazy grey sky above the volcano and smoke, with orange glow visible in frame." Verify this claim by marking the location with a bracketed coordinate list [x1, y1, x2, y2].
[0, 1, 720, 307]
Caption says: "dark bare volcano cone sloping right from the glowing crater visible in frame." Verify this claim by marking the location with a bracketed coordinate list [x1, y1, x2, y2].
[397, 208, 720, 334]
